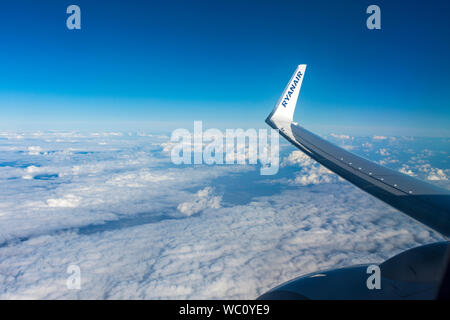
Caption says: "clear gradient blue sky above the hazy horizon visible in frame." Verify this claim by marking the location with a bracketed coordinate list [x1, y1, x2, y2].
[0, 0, 450, 136]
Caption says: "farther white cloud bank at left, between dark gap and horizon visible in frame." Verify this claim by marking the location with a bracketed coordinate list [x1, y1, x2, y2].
[0, 134, 255, 245]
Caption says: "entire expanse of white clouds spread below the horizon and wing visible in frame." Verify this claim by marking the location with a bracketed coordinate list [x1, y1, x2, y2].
[0, 132, 448, 299]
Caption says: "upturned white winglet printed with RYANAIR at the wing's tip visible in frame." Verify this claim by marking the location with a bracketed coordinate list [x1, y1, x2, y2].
[266, 64, 306, 127]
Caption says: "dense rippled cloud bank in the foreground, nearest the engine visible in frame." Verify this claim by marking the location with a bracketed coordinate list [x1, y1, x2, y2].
[0, 184, 441, 299]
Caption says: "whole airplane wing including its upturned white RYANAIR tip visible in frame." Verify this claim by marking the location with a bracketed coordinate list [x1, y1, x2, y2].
[266, 64, 450, 239]
